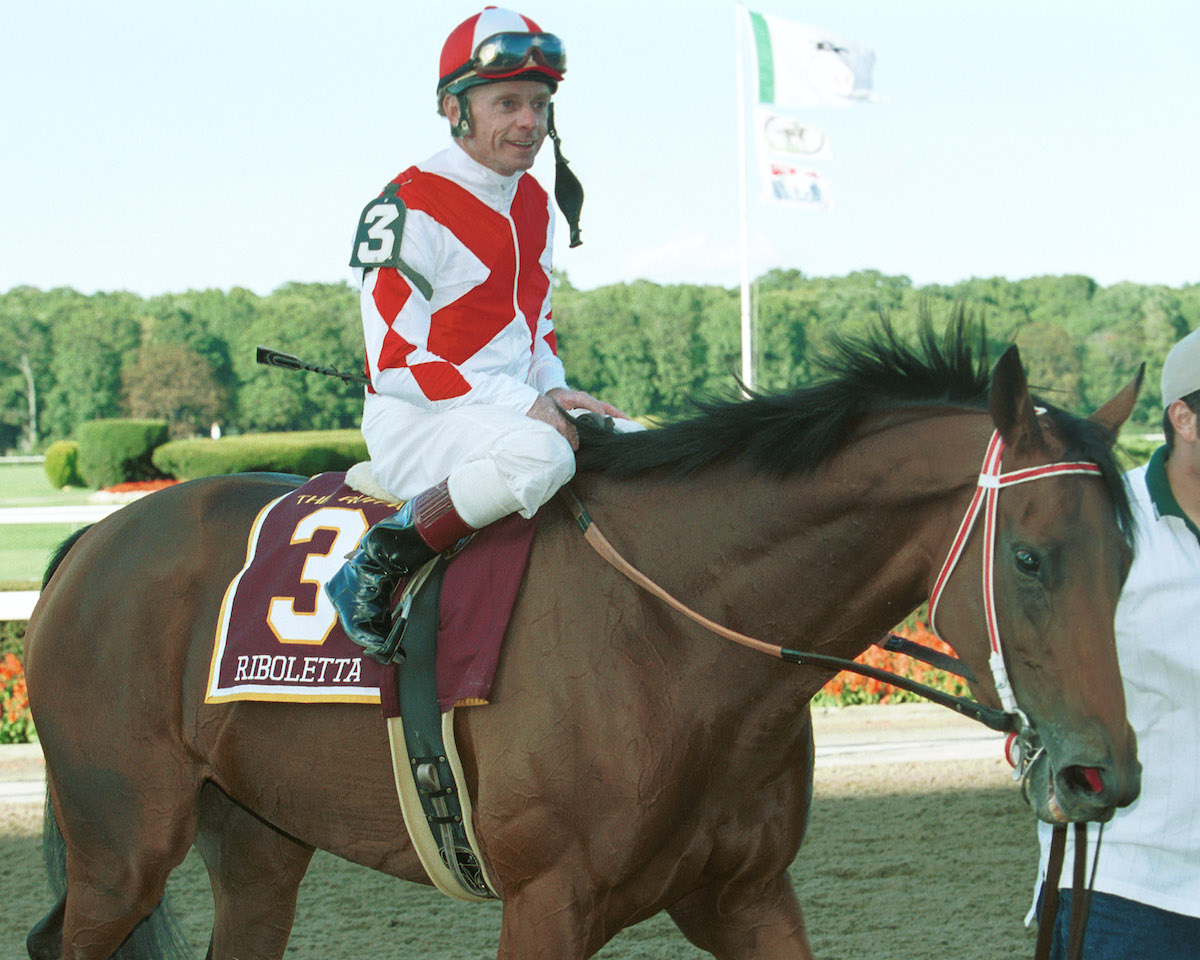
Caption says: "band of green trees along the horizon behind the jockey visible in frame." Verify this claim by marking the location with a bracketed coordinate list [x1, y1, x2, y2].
[0, 270, 1200, 452]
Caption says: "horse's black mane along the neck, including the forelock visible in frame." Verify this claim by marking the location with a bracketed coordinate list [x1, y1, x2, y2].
[578, 319, 1132, 533]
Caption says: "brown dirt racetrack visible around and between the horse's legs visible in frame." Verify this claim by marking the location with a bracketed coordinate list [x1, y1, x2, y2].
[0, 758, 1037, 960]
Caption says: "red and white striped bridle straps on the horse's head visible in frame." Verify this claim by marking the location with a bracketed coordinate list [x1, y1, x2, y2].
[929, 430, 1100, 726]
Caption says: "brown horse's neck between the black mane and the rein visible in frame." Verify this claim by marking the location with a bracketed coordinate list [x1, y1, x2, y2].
[583, 415, 986, 656]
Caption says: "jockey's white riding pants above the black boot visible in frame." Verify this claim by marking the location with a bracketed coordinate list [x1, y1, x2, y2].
[362, 394, 575, 528]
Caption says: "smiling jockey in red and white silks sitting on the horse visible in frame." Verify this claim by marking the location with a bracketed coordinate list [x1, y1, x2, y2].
[325, 7, 637, 654]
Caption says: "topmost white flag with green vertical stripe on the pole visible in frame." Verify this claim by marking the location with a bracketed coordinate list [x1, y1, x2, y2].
[746, 11, 875, 107]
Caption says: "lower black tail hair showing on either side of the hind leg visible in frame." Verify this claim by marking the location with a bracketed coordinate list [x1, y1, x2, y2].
[26, 796, 192, 960]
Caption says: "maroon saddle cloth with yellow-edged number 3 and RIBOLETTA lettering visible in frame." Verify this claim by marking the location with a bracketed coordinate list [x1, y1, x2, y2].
[205, 473, 536, 712]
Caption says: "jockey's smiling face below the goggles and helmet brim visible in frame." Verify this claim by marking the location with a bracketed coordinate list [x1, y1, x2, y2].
[446, 80, 550, 176]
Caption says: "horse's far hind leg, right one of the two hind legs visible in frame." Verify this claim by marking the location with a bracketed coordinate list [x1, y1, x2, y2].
[196, 784, 313, 960]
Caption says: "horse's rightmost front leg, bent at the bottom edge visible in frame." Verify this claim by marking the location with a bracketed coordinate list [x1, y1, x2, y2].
[667, 874, 812, 960]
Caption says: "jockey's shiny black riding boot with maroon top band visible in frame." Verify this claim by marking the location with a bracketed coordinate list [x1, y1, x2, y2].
[325, 480, 474, 659]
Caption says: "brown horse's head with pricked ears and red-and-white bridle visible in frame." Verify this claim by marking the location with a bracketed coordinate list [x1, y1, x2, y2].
[938, 347, 1141, 822]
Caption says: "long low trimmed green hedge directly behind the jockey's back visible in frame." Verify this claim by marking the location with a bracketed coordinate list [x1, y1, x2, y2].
[154, 430, 367, 480]
